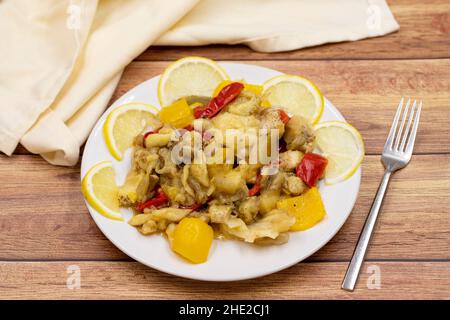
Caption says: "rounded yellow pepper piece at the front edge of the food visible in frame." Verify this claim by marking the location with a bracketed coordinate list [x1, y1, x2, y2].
[172, 218, 214, 263]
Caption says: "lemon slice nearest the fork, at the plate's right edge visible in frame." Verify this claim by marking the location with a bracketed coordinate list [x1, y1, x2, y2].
[314, 121, 364, 185]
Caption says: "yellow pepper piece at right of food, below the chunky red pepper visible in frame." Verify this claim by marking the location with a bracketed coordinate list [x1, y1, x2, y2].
[277, 188, 326, 231]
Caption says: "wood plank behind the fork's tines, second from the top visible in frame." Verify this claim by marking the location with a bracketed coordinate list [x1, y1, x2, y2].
[113, 59, 450, 154]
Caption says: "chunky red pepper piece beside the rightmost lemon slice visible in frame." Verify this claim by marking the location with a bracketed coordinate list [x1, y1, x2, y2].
[296, 153, 328, 187]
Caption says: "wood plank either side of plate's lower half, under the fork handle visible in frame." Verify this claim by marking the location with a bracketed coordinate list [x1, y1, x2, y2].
[0, 155, 450, 261]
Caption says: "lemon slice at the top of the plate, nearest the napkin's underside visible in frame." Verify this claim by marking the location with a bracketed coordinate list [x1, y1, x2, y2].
[158, 57, 229, 106]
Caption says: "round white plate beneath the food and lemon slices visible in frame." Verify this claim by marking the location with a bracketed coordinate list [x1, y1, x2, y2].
[81, 63, 361, 281]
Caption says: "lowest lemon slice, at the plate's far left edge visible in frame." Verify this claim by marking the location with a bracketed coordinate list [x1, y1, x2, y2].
[81, 161, 123, 220]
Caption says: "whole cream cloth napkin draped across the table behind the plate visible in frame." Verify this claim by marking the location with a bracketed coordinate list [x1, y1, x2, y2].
[0, 0, 399, 165]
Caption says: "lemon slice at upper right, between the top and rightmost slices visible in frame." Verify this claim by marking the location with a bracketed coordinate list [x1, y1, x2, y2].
[263, 75, 324, 123]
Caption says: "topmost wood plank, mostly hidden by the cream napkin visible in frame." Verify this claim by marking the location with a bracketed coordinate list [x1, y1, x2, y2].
[137, 0, 450, 60]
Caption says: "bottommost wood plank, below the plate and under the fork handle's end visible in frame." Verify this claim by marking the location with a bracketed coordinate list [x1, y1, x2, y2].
[0, 261, 450, 300]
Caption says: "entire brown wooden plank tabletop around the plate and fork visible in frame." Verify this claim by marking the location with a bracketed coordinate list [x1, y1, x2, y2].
[0, 0, 450, 299]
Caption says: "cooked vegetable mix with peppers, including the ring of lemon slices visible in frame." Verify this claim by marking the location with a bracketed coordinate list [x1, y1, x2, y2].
[83, 57, 364, 263]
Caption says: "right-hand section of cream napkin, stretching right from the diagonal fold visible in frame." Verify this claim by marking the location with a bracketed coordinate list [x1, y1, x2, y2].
[155, 0, 399, 52]
